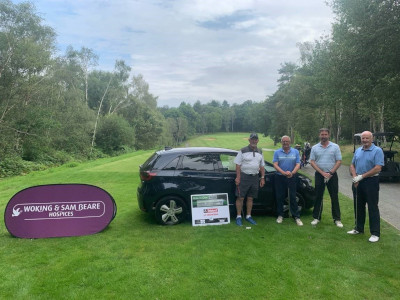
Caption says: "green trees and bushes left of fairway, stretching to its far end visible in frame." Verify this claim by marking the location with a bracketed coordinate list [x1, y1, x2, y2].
[0, 0, 268, 177]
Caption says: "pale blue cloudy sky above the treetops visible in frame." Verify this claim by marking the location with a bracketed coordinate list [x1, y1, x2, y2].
[27, 0, 334, 107]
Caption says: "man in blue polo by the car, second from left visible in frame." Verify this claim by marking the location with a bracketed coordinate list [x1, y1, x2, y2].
[272, 135, 303, 226]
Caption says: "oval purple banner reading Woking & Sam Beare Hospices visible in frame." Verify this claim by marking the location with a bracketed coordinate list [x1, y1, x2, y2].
[4, 184, 117, 238]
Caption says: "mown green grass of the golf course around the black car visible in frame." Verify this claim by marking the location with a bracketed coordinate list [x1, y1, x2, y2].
[0, 134, 400, 299]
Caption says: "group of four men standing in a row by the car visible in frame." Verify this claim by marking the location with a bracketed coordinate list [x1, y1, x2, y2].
[235, 128, 384, 242]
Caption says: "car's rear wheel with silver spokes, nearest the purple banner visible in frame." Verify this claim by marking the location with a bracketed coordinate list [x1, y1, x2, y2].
[155, 196, 187, 225]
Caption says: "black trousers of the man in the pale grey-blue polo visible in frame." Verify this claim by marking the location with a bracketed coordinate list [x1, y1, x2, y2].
[313, 172, 340, 221]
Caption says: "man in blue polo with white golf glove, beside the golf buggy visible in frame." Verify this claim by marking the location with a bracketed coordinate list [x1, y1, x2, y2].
[347, 131, 384, 243]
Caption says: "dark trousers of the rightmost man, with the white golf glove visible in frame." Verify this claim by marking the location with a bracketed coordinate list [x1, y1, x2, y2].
[353, 176, 381, 236]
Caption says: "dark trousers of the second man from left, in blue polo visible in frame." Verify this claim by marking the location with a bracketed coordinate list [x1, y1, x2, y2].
[275, 174, 300, 218]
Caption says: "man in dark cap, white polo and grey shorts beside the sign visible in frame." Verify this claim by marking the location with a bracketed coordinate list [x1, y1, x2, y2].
[234, 133, 265, 226]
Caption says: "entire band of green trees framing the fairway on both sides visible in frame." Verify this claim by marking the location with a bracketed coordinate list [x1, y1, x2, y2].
[0, 0, 400, 176]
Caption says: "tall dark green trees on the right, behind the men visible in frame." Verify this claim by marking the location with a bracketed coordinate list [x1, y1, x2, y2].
[265, 0, 400, 141]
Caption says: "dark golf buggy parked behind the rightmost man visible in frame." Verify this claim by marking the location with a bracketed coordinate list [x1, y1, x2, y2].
[353, 132, 400, 182]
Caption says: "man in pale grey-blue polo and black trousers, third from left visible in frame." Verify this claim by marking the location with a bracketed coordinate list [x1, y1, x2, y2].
[310, 128, 343, 228]
